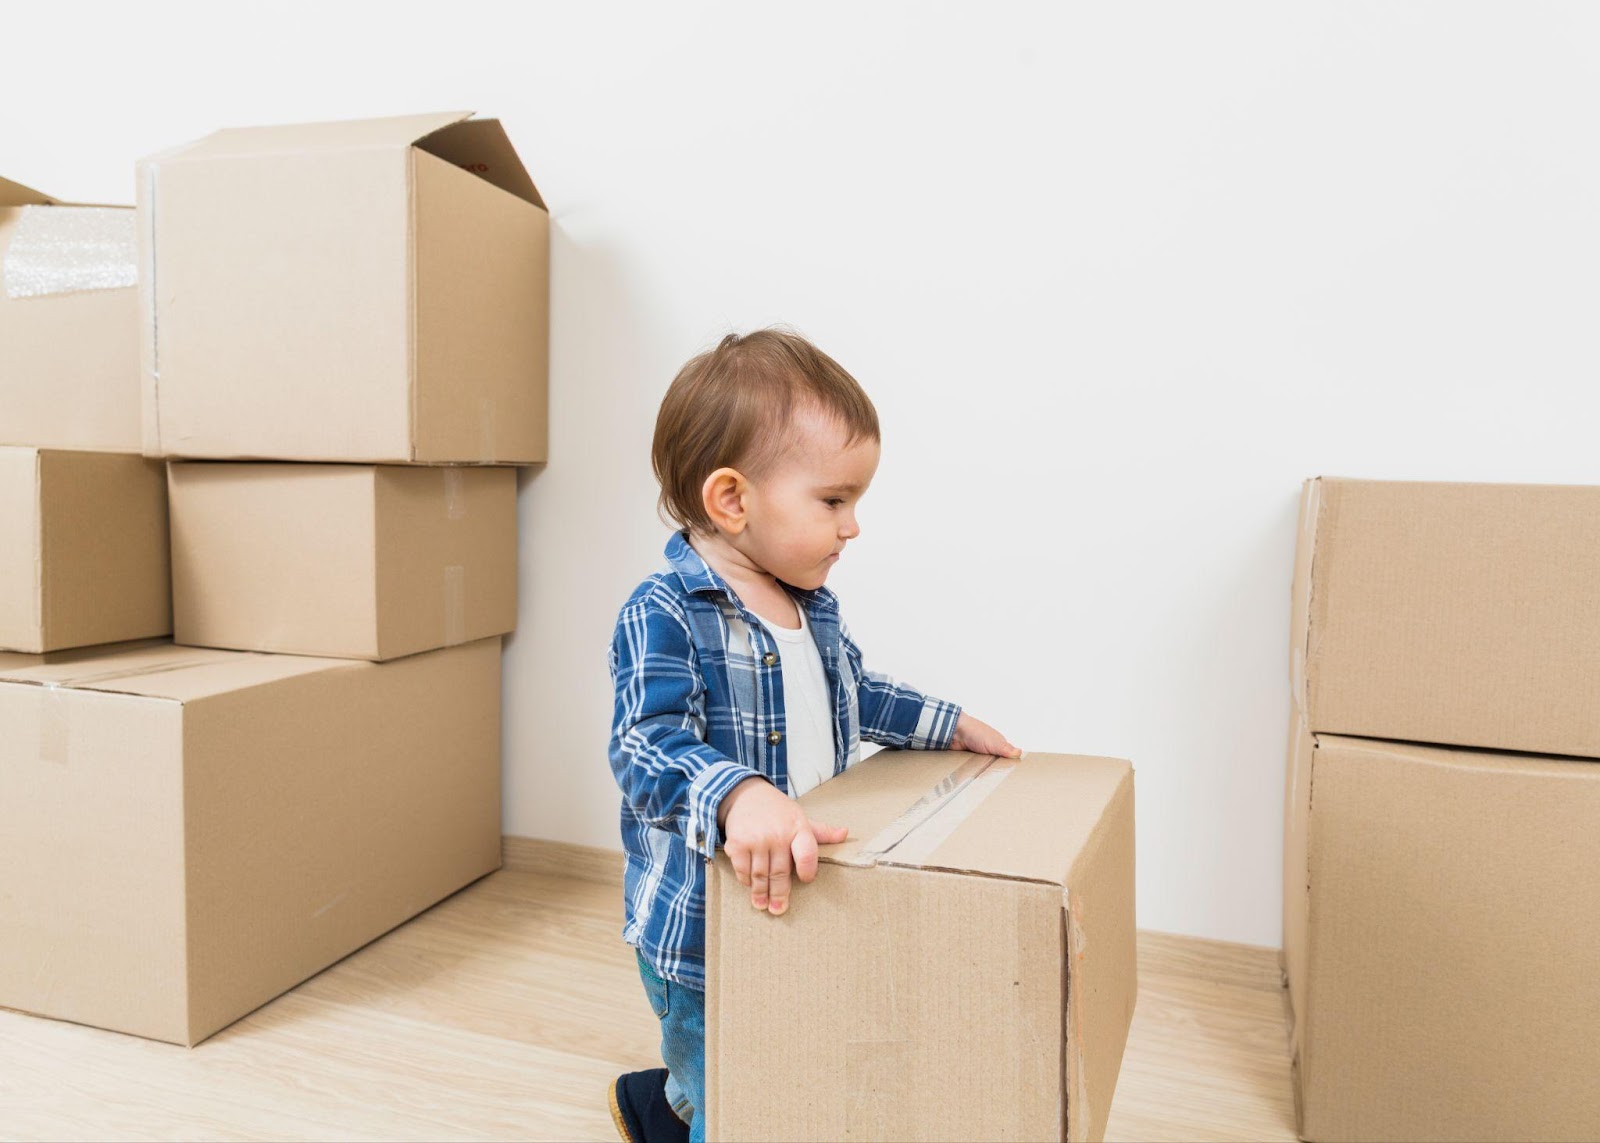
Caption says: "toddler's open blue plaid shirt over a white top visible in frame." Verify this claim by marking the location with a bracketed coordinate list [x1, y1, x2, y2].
[611, 531, 962, 989]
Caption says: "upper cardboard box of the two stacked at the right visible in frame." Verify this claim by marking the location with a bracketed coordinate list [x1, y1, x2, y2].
[1291, 477, 1600, 757]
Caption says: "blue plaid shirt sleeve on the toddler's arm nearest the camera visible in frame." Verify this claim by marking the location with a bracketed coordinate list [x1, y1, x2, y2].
[610, 596, 760, 858]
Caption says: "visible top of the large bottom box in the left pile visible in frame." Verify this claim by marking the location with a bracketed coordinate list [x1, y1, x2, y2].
[0, 642, 356, 703]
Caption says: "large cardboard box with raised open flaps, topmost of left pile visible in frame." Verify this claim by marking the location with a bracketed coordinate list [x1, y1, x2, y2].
[139, 112, 550, 464]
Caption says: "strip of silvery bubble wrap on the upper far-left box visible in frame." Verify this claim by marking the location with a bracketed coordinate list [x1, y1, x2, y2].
[0, 207, 139, 298]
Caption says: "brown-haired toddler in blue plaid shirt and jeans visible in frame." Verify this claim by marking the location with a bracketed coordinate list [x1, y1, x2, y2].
[610, 330, 1021, 1143]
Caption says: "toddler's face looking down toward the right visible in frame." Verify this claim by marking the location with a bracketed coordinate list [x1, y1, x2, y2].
[734, 410, 878, 589]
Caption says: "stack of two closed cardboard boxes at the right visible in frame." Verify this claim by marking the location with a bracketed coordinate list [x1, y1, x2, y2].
[1283, 479, 1600, 1141]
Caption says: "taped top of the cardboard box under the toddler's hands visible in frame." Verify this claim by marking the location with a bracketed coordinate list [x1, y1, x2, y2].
[800, 751, 1133, 885]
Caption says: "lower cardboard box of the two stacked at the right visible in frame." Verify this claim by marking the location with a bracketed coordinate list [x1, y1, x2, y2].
[1285, 722, 1600, 1141]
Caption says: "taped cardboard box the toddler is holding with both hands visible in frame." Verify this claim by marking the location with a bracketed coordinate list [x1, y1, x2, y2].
[706, 751, 1138, 1140]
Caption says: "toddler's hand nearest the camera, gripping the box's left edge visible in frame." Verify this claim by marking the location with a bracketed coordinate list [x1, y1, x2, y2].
[717, 778, 850, 917]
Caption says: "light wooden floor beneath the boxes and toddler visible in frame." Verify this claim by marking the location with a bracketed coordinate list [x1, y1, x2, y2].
[0, 855, 1294, 1140]
